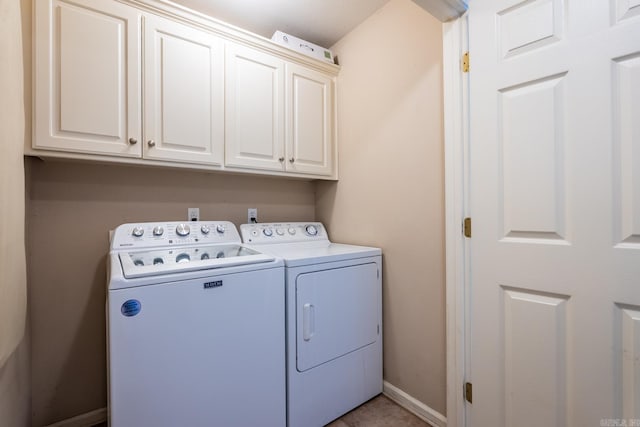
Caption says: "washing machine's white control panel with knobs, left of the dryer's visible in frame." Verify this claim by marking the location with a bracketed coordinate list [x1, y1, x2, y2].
[111, 221, 241, 249]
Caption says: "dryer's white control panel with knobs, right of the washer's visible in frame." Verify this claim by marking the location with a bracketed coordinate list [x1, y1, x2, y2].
[240, 222, 329, 244]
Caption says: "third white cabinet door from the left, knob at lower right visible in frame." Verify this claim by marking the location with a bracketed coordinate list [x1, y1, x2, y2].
[225, 44, 284, 171]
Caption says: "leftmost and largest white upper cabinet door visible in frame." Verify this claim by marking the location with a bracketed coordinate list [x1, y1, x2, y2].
[33, 0, 142, 157]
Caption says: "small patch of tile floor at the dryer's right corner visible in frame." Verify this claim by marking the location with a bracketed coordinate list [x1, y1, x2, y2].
[327, 394, 430, 427]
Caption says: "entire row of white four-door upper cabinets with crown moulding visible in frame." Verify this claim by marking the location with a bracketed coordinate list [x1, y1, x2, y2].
[32, 0, 339, 179]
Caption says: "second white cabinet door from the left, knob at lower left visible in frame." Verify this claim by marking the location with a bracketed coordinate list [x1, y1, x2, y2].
[144, 16, 224, 165]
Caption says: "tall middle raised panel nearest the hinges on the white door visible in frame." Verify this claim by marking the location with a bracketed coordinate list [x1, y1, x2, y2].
[498, 73, 568, 244]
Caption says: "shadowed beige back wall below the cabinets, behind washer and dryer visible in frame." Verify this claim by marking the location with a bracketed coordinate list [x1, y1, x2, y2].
[28, 159, 315, 427]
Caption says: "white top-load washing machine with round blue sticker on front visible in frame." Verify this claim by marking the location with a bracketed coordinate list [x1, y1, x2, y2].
[107, 221, 286, 427]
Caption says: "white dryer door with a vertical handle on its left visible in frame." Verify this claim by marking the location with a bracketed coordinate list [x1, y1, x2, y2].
[296, 263, 380, 372]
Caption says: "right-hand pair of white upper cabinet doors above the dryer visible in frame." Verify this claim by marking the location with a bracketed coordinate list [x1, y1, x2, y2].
[225, 44, 335, 176]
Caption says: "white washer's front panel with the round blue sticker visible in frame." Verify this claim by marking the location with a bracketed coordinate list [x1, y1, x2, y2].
[108, 268, 285, 427]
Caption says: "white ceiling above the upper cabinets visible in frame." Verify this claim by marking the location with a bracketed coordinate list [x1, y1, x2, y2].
[173, 0, 389, 47]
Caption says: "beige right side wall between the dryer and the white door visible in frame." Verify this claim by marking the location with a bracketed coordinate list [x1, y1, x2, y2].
[316, 0, 446, 414]
